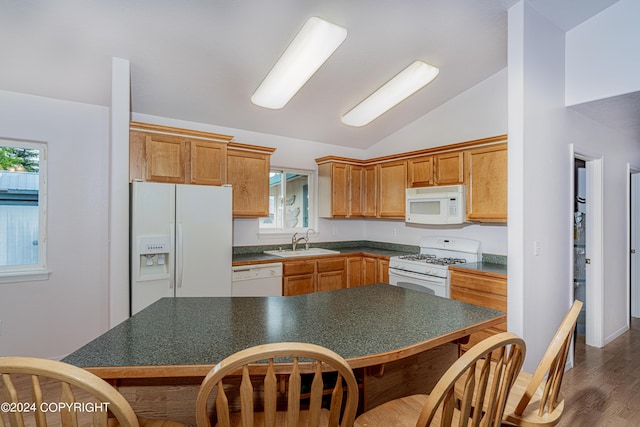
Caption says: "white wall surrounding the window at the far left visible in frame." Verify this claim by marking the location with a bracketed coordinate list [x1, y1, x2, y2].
[0, 91, 109, 358]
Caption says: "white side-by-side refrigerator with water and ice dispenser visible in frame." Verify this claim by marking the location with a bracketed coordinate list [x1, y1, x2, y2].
[131, 181, 232, 315]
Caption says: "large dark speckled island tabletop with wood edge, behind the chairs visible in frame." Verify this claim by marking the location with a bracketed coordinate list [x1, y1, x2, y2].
[63, 284, 504, 378]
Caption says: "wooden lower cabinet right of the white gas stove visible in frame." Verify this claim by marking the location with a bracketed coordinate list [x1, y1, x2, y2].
[449, 267, 507, 351]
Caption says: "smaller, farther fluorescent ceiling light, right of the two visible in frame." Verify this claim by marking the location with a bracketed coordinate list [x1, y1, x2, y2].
[342, 61, 440, 127]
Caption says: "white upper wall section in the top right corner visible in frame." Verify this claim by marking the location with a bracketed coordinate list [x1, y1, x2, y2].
[566, 0, 640, 105]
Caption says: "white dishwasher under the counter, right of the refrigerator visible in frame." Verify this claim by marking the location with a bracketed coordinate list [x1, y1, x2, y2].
[231, 262, 282, 297]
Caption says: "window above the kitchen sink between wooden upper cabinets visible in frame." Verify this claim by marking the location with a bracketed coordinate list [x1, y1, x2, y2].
[260, 170, 315, 233]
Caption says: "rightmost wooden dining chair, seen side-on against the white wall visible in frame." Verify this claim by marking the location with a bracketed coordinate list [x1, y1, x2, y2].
[505, 300, 582, 426]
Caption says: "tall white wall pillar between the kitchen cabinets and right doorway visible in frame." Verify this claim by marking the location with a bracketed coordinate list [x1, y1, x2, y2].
[508, 2, 572, 372]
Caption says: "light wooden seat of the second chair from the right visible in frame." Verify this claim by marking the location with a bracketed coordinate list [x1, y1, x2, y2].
[354, 394, 429, 427]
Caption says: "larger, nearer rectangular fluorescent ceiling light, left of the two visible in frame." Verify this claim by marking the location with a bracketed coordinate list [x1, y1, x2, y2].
[251, 16, 347, 109]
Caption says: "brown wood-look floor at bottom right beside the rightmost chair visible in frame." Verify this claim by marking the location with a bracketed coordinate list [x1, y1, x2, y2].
[558, 319, 640, 427]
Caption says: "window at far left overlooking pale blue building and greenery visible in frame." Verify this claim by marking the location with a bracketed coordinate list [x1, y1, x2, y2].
[0, 139, 47, 282]
